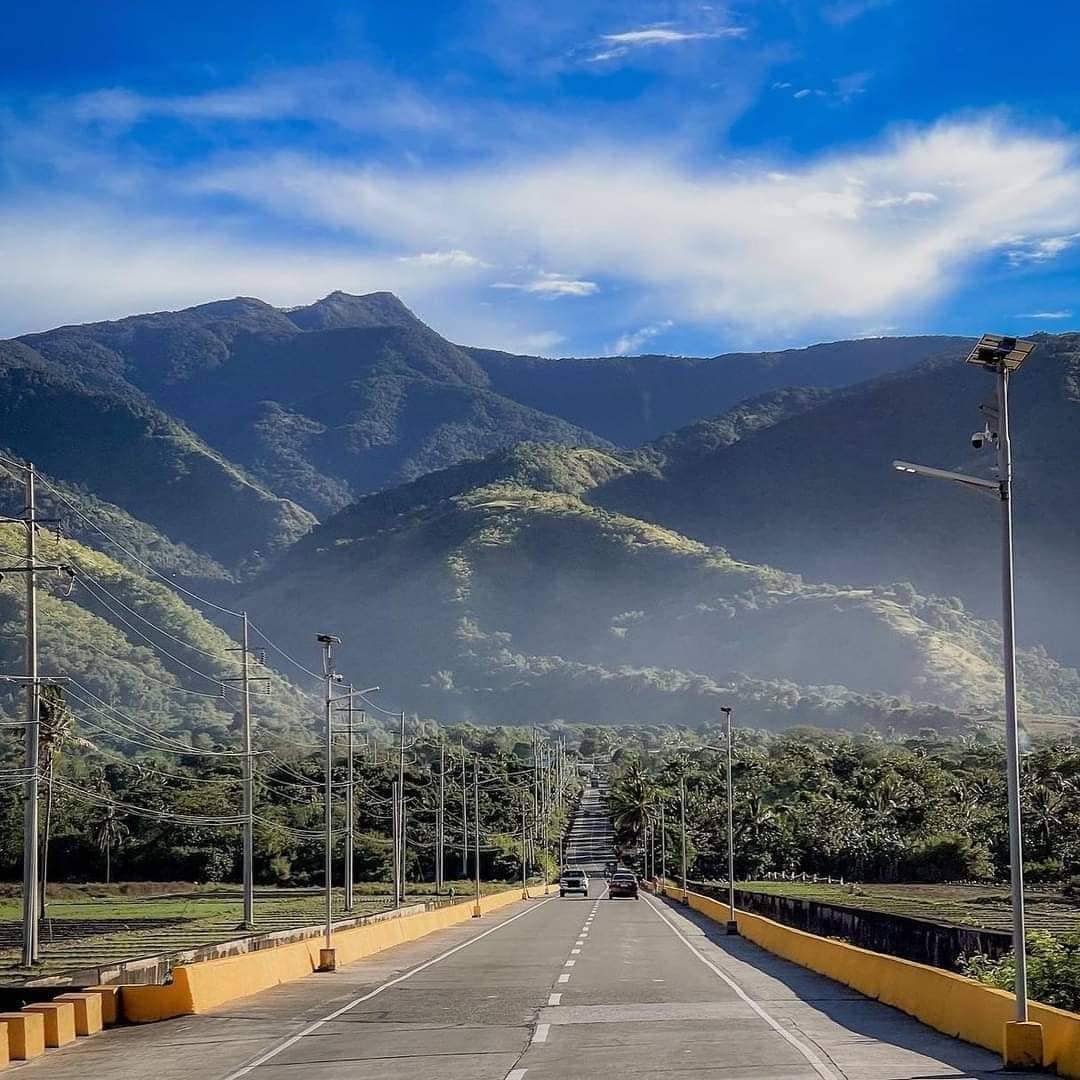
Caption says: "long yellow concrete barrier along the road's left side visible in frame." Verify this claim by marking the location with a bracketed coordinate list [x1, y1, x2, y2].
[121, 889, 531, 1024]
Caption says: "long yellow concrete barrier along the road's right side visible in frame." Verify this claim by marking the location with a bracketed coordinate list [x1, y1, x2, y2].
[663, 886, 1080, 1080]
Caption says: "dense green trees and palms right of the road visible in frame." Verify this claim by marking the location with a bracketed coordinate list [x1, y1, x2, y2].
[611, 729, 1080, 882]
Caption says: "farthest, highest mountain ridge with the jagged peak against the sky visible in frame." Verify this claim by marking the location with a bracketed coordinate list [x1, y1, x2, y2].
[14, 292, 950, 516]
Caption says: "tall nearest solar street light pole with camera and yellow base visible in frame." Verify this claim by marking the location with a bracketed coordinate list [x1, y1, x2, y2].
[893, 334, 1042, 1068]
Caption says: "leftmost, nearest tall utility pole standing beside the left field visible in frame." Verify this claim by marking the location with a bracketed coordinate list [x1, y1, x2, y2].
[23, 462, 41, 968]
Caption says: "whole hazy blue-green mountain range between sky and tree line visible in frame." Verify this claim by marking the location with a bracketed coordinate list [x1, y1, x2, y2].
[0, 293, 1080, 733]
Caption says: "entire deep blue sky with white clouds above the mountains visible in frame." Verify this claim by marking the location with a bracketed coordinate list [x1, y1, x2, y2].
[0, 0, 1080, 355]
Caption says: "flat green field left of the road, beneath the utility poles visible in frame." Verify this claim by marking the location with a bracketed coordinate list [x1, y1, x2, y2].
[0, 881, 522, 984]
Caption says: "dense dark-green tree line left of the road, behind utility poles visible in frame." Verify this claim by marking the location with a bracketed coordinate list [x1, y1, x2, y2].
[0, 717, 575, 886]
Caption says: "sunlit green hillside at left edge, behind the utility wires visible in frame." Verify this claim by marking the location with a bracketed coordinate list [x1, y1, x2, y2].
[0, 525, 310, 754]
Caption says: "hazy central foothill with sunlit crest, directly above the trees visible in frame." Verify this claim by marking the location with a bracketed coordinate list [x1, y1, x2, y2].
[238, 446, 1080, 726]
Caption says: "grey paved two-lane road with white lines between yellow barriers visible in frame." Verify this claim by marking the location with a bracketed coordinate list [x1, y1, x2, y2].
[25, 881, 1032, 1080]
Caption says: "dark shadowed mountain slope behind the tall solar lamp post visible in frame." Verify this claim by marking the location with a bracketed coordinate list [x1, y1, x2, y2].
[594, 334, 1080, 663]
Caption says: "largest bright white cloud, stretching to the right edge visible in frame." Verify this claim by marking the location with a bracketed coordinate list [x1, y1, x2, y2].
[197, 120, 1080, 334]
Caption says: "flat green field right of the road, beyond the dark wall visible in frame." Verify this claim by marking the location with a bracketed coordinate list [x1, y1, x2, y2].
[739, 881, 1080, 933]
